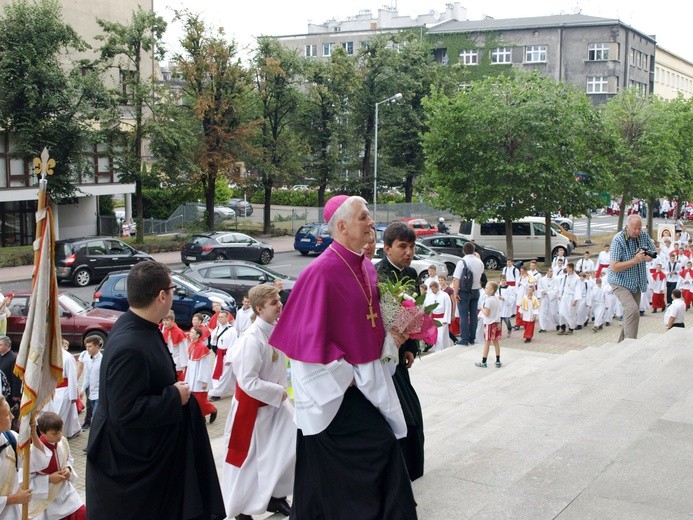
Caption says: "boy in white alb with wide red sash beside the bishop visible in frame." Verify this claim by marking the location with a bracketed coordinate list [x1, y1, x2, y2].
[222, 284, 296, 520]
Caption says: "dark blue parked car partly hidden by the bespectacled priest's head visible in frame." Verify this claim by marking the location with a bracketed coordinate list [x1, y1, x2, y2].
[91, 271, 236, 329]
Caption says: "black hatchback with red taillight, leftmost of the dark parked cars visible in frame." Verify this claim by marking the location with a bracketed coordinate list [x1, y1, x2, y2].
[55, 237, 153, 287]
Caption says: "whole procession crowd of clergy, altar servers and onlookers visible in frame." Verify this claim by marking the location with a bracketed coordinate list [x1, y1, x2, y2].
[0, 201, 693, 520]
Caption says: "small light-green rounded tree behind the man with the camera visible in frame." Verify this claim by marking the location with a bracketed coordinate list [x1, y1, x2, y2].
[603, 89, 678, 229]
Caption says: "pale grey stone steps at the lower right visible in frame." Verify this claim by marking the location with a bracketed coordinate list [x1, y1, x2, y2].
[410, 329, 693, 520]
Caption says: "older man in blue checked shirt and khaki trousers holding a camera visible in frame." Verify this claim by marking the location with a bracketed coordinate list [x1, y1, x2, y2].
[609, 214, 657, 342]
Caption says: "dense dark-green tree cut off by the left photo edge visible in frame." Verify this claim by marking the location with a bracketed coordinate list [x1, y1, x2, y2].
[0, 0, 109, 201]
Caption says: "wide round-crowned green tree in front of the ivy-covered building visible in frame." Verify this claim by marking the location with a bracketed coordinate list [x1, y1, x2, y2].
[423, 73, 601, 258]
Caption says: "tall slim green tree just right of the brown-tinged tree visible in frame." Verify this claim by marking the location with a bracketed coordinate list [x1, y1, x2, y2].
[253, 37, 304, 234]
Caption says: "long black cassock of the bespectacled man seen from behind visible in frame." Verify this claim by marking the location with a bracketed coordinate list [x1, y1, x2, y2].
[86, 312, 226, 520]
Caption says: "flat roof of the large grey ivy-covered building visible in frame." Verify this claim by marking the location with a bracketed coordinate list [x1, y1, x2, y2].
[428, 14, 654, 41]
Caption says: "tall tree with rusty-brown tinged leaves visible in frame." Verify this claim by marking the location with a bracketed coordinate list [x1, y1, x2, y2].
[176, 11, 258, 230]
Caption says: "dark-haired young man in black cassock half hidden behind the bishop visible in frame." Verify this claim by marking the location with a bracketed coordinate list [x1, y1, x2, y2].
[376, 222, 424, 480]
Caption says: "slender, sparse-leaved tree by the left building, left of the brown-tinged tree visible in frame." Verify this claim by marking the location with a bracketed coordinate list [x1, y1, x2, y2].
[97, 7, 166, 243]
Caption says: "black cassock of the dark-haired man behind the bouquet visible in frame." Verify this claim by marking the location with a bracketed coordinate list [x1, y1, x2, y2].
[376, 258, 424, 480]
